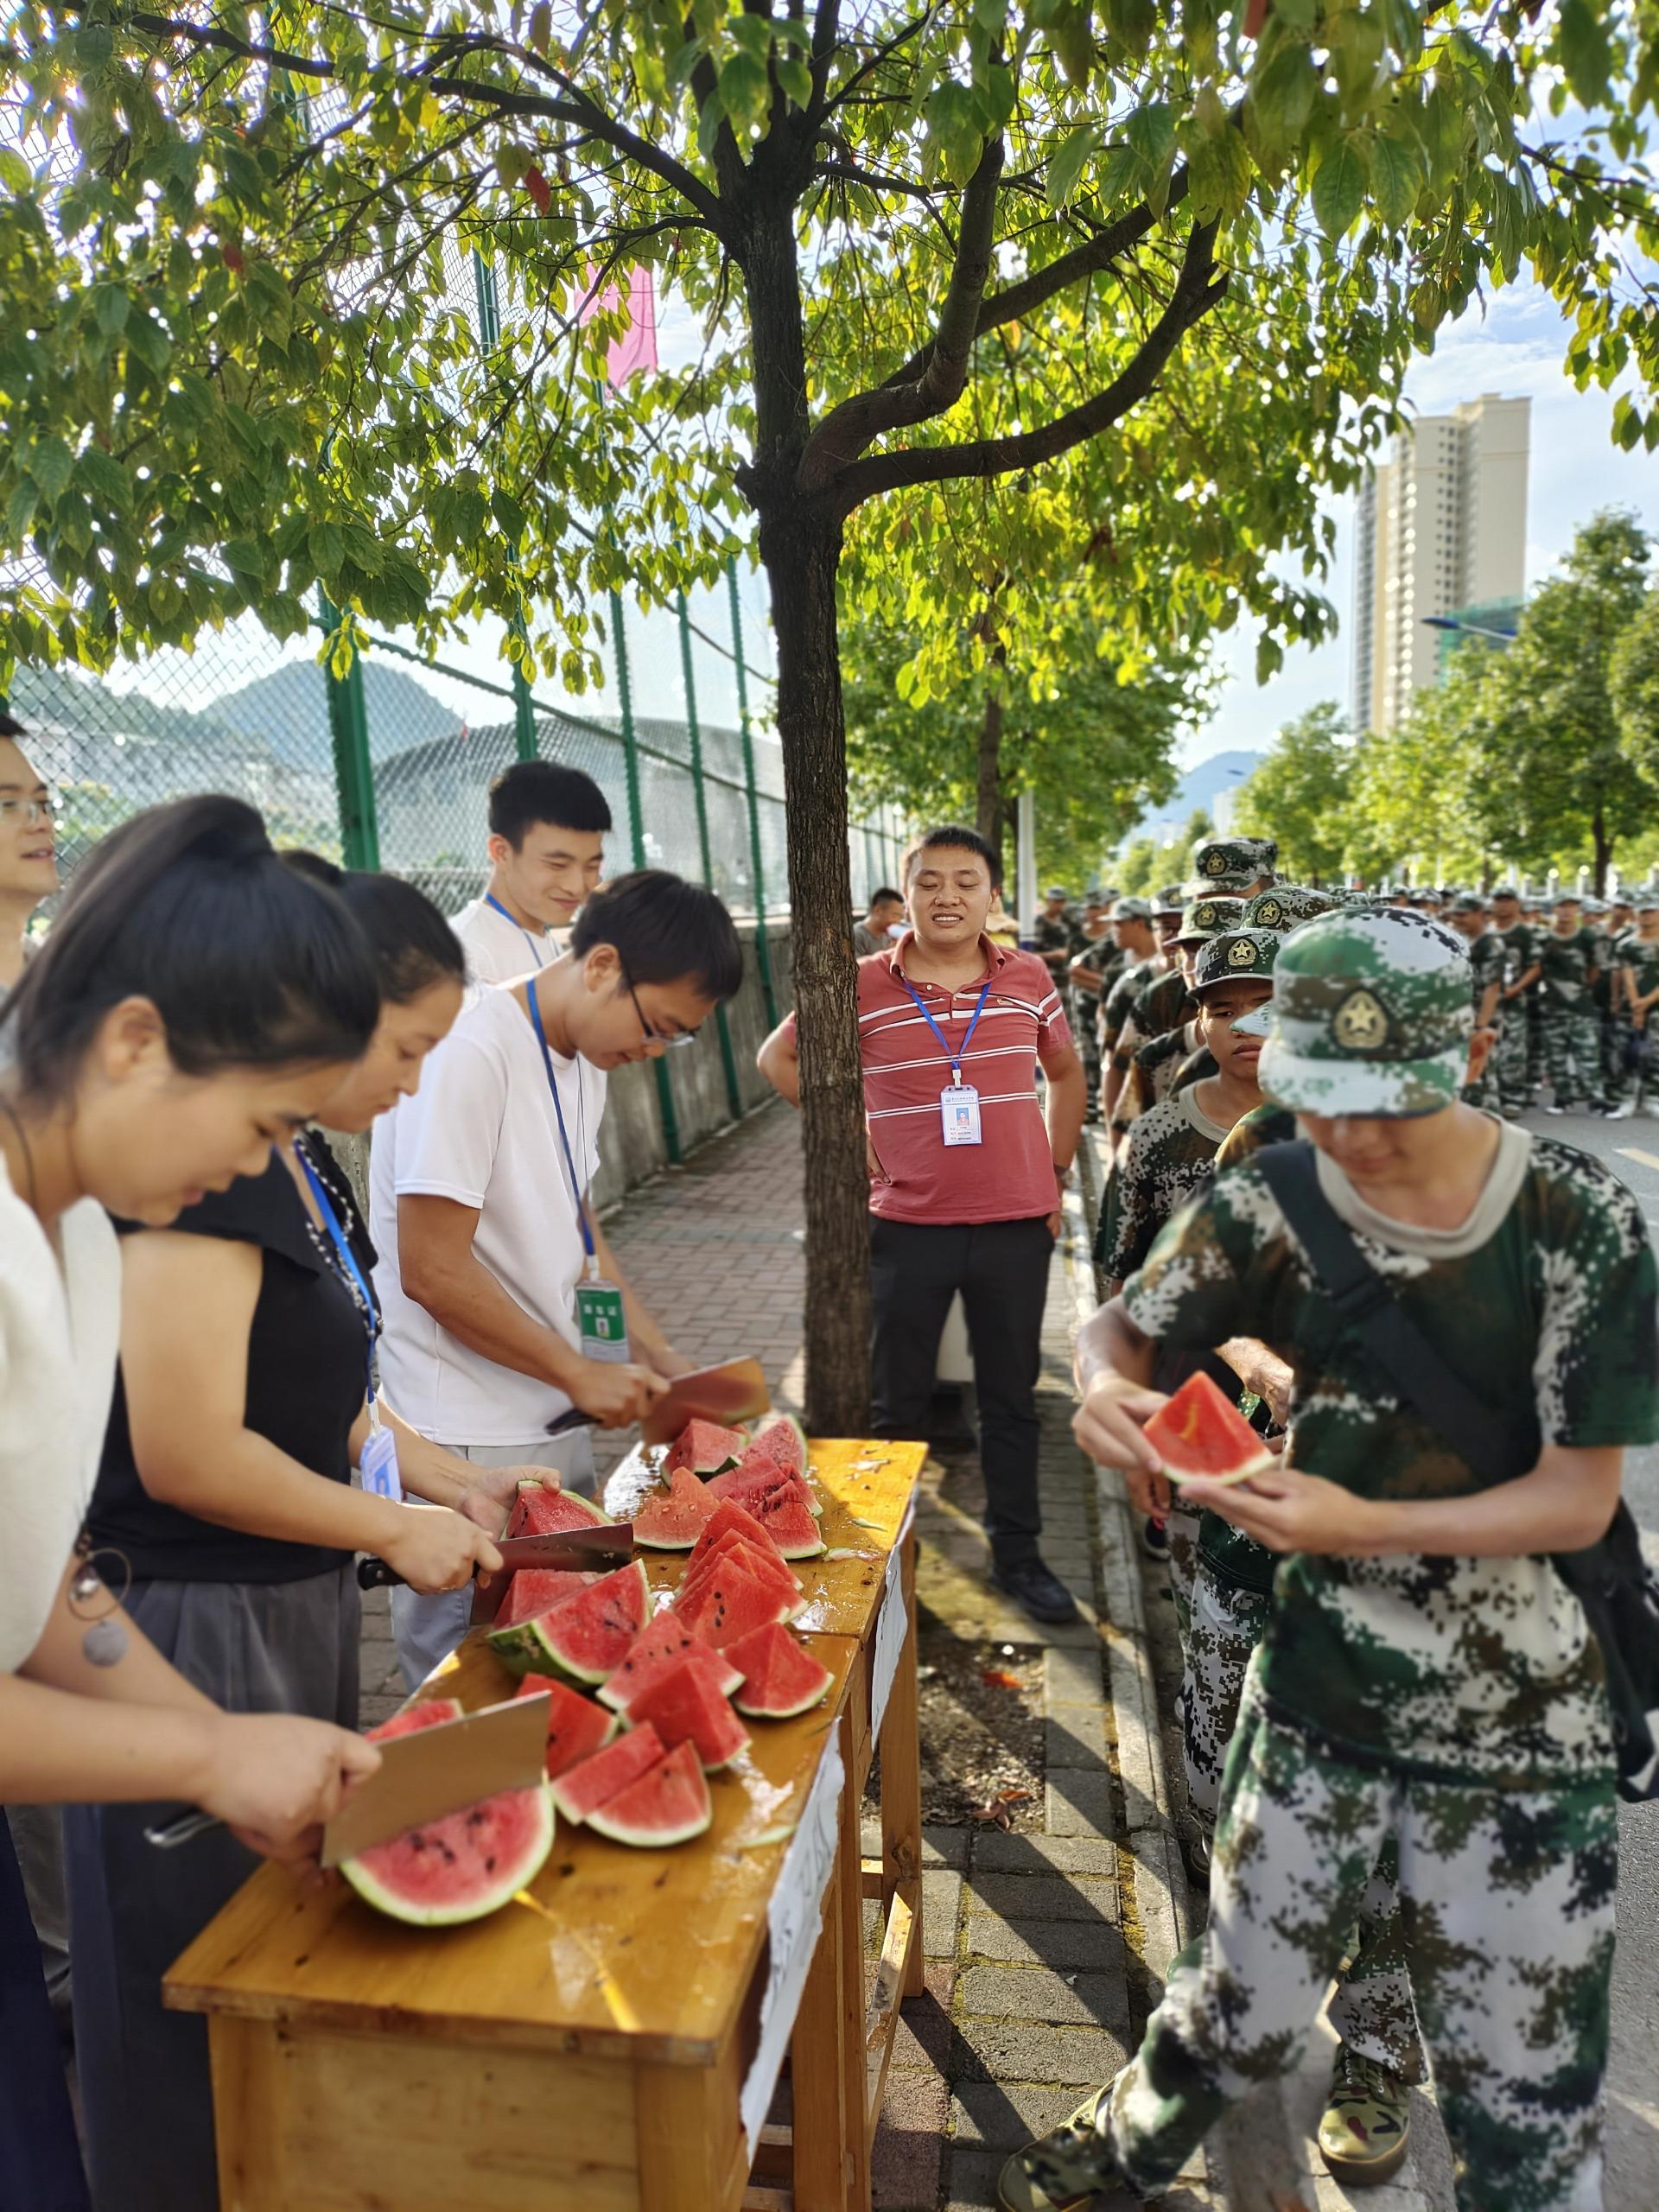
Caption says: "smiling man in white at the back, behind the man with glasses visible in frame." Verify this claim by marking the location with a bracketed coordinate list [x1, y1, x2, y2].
[451, 761, 611, 982]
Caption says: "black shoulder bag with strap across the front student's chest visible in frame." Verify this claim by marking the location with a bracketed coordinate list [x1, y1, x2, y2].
[1255, 1144, 1659, 1805]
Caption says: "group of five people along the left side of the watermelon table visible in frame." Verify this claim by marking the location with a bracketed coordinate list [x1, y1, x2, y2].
[0, 721, 741, 2212]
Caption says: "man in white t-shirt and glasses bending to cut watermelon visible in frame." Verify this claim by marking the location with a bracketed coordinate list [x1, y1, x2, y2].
[370, 869, 743, 1688]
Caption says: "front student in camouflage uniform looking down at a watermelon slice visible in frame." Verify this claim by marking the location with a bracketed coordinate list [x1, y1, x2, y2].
[998, 916, 1659, 2212]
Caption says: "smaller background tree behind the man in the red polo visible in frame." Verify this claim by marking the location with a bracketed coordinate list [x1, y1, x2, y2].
[841, 617, 1212, 885]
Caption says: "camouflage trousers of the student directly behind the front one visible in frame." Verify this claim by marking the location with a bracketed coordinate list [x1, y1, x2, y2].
[1181, 1560, 1422, 2082]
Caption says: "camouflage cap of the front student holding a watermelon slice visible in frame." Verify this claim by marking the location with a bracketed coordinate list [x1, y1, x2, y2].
[1261, 907, 1473, 1117]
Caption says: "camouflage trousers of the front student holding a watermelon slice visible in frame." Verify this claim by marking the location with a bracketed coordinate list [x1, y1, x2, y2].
[1099, 1688, 1619, 2212]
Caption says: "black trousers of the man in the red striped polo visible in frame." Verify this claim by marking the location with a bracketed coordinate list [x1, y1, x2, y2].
[869, 1214, 1055, 1561]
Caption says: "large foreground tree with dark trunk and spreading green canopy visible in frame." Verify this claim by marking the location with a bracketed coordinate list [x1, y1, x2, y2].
[0, 0, 1659, 1433]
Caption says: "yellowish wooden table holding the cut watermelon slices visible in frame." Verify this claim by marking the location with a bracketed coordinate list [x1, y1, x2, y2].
[166, 1442, 938, 2212]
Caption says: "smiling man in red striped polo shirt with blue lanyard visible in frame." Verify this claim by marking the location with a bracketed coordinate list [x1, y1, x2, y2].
[759, 827, 1086, 1621]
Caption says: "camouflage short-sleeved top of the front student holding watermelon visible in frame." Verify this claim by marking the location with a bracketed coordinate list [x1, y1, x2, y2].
[1123, 1128, 1659, 1789]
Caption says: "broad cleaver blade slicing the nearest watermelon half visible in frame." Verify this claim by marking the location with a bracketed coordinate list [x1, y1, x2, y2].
[143, 1690, 550, 1867]
